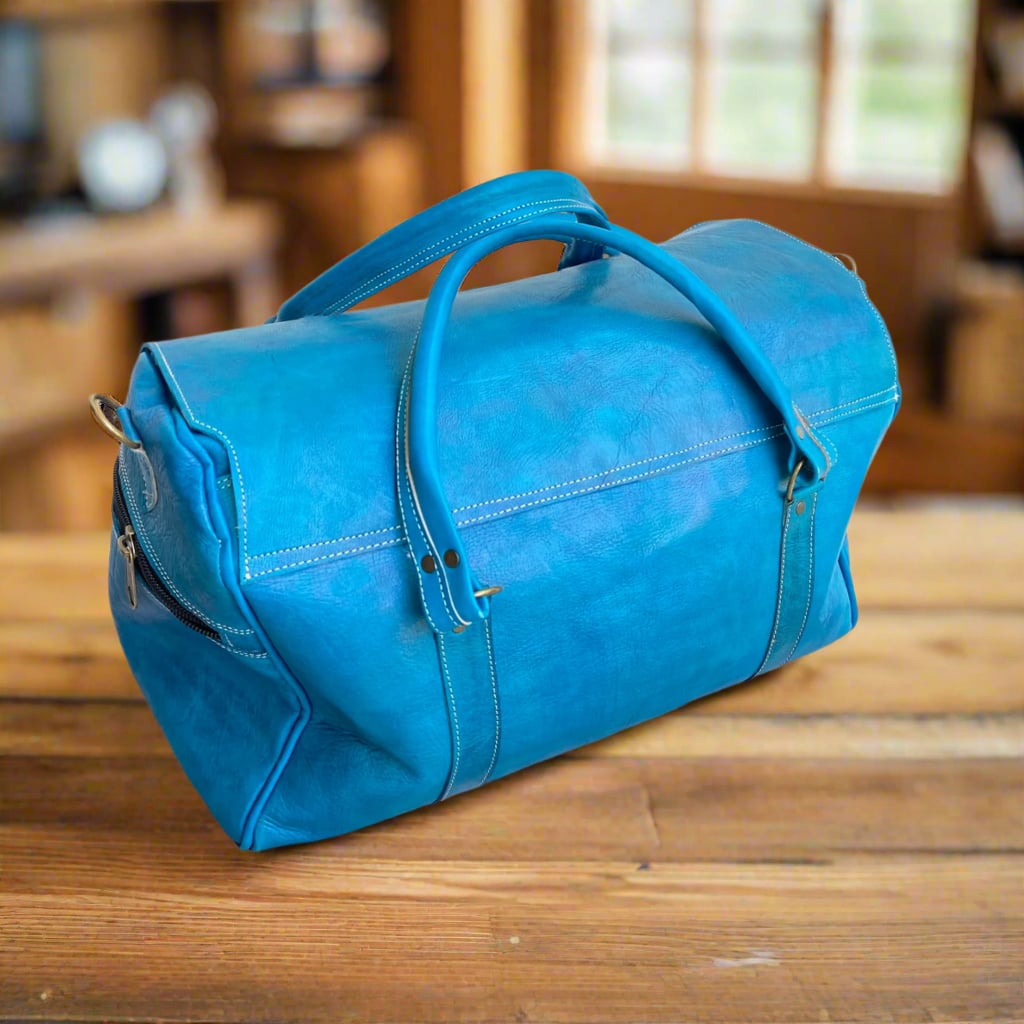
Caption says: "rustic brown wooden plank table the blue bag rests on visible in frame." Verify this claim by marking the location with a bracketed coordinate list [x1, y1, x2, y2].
[0, 508, 1024, 1024]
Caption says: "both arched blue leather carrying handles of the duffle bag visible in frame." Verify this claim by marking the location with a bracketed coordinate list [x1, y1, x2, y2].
[278, 172, 828, 632]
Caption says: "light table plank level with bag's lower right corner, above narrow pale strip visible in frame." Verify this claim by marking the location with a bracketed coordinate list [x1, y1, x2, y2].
[8, 611, 1024, 715]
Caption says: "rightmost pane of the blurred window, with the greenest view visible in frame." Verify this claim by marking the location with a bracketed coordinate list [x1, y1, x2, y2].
[826, 0, 974, 190]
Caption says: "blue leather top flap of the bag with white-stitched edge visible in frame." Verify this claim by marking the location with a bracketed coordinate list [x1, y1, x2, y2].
[129, 221, 899, 579]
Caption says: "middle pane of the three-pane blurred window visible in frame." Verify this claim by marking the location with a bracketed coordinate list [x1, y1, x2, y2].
[701, 0, 818, 178]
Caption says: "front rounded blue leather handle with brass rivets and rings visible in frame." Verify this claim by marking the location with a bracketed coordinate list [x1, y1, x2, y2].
[396, 217, 828, 631]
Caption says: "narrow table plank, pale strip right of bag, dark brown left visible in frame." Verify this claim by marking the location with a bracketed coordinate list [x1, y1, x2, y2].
[0, 699, 1024, 760]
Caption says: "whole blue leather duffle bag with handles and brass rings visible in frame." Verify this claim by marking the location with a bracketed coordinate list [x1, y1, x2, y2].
[94, 171, 900, 850]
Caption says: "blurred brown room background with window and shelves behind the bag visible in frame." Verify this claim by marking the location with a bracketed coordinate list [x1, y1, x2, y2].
[0, 0, 1024, 530]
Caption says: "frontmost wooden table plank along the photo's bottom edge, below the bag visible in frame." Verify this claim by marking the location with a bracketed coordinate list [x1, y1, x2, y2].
[0, 857, 1024, 1022]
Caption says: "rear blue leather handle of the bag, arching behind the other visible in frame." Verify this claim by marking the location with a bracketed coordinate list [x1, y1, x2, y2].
[274, 171, 608, 321]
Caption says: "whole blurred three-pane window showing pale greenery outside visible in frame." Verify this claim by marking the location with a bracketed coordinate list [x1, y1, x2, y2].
[583, 0, 975, 193]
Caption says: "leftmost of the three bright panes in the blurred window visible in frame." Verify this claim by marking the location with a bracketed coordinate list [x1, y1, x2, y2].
[585, 0, 692, 169]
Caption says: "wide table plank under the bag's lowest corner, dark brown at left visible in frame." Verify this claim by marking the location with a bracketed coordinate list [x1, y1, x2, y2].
[0, 757, 1024, 869]
